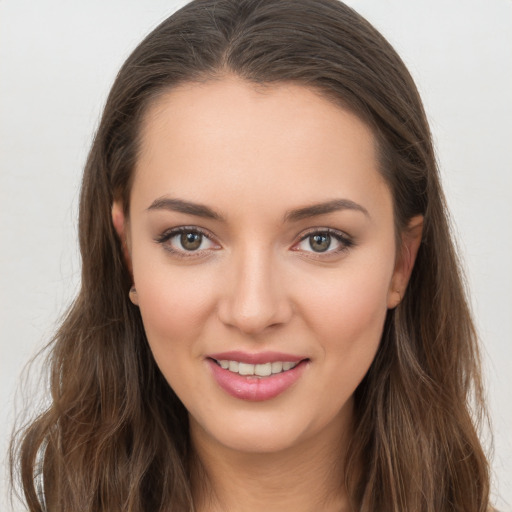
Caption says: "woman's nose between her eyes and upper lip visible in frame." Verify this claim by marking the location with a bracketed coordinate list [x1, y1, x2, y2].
[218, 250, 293, 335]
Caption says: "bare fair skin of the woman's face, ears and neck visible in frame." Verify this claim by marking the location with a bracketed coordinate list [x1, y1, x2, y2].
[112, 76, 422, 512]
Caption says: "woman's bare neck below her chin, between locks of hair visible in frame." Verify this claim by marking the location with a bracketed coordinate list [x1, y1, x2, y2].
[191, 410, 349, 512]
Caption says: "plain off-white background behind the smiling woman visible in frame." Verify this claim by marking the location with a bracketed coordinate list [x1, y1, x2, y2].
[0, 0, 512, 511]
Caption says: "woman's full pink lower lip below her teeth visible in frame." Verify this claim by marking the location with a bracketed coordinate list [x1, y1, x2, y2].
[207, 359, 307, 402]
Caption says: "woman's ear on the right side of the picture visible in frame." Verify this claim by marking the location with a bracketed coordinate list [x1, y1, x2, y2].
[388, 215, 423, 309]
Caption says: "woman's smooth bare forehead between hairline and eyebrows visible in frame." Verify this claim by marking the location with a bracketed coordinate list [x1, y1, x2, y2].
[132, 77, 387, 217]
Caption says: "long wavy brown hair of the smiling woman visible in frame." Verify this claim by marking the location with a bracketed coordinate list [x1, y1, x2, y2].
[11, 0, 489, 512]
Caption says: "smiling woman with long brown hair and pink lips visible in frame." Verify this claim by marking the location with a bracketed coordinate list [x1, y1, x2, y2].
[10, 0, 489, 512]
